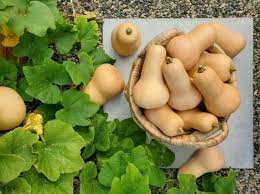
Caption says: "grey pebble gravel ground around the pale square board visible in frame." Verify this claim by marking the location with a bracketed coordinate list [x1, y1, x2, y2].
[59, 0, 260, 194]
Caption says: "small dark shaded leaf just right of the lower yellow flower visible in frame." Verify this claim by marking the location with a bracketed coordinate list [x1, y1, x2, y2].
[36, 104, 62, 123]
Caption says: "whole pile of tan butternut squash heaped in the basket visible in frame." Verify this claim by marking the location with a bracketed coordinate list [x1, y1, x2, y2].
[133, 23, 246, 137]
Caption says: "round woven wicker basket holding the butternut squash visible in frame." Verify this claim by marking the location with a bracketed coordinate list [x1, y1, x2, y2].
[125, 28, 236, 148]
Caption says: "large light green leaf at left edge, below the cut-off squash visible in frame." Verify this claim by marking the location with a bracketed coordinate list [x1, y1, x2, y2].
[0, 128, 38, 183]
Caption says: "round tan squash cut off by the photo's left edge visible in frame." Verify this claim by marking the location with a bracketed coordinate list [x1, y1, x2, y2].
[0, 86, 26, 131]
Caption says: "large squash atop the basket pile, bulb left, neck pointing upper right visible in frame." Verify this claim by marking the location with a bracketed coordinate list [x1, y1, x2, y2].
[166, 24, 216, 70]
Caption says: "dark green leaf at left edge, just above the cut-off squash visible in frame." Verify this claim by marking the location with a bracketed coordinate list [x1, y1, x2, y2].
[0, 57, 18, 81]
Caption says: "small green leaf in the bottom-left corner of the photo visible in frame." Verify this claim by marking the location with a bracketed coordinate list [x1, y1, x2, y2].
[0, 177, 31, 194]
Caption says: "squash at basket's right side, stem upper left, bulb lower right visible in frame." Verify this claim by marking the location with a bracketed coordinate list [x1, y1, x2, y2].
[193, 66, 240, 117]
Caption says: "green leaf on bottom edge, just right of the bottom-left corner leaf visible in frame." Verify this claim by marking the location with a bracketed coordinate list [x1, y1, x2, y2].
[23, 168, 73, 194]
